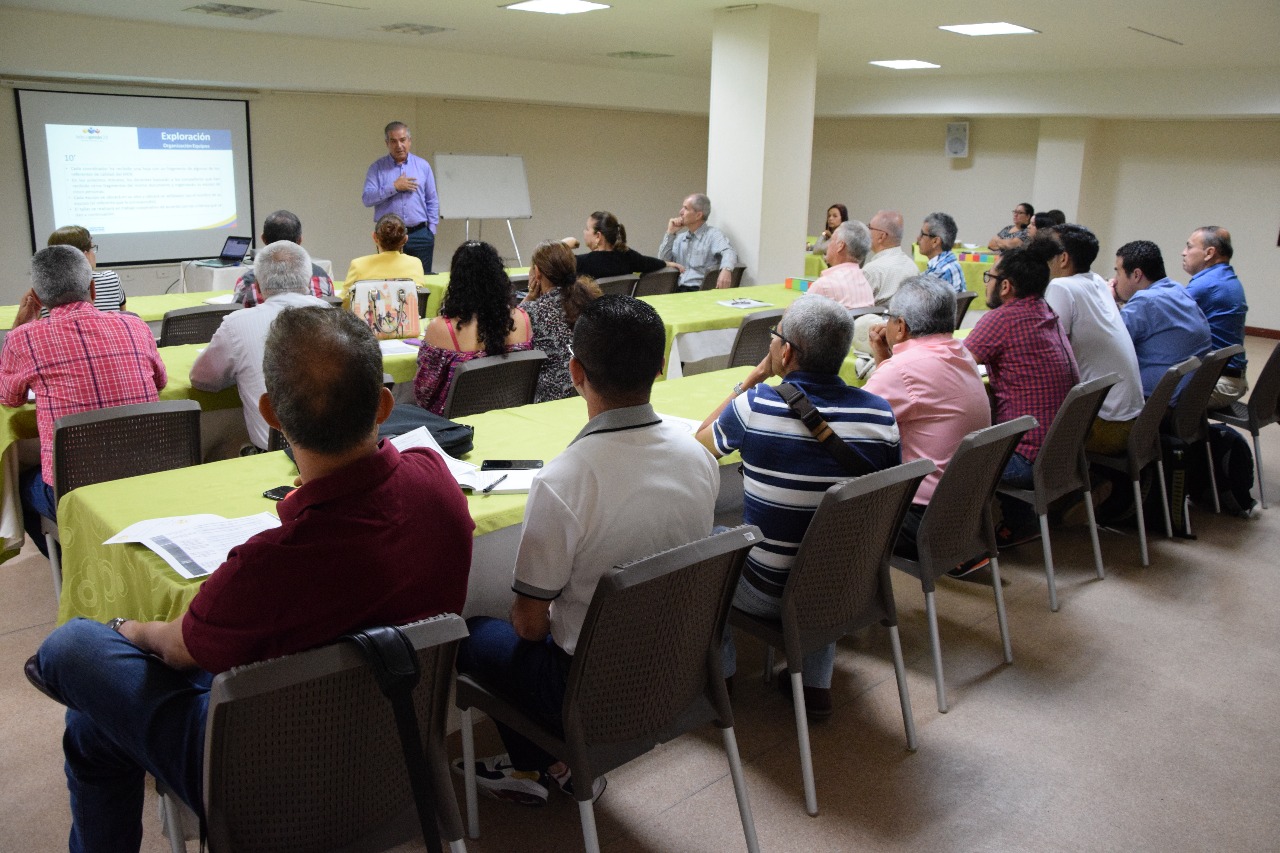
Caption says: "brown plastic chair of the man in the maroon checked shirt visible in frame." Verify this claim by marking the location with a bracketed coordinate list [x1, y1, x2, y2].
[996, 373, 1120, 612]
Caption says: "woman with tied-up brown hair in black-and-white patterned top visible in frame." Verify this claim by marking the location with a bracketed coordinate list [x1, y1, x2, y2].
[524, 240, 600, 402]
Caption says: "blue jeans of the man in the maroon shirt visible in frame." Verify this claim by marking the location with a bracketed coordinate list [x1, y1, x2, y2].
[37, 619, 212, 853]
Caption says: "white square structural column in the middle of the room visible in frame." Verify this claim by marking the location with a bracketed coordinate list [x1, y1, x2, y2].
[707, 5, 818, 283]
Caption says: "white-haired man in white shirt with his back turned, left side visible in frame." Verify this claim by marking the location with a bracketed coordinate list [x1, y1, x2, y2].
[191, 240, 329, 450]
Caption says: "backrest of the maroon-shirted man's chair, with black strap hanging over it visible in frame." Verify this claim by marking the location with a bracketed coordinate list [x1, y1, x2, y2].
[197, 613, 467, 850]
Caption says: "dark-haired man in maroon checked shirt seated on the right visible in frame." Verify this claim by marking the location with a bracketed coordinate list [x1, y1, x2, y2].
[964, 242, 1080, 546]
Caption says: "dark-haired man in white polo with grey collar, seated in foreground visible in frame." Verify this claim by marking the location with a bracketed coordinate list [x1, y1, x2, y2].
[456, 296, 719, 806]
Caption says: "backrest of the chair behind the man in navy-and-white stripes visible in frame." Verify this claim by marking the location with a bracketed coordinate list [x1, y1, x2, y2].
[782, 459, 934, 649]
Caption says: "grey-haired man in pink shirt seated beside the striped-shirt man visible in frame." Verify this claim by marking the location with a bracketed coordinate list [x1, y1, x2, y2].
[863, 274, 991, 576]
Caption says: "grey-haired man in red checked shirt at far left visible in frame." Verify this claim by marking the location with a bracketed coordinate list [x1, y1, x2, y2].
[0, 246, 168, 556]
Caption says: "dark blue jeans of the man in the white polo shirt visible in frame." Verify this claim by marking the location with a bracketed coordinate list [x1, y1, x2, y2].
[457, 616, 573, 770]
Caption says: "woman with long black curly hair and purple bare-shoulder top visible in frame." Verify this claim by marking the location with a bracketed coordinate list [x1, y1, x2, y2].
[413, 241, 534, 415]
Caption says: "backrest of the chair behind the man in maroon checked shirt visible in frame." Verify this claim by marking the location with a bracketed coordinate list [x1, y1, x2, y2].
[1032, 373, 1120, 504]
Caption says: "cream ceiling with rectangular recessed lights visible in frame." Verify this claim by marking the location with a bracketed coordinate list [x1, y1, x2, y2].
[0, 0, 1280, 84]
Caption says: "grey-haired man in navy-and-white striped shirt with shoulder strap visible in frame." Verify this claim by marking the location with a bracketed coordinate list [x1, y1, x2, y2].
[698, 296, 901, 717]
